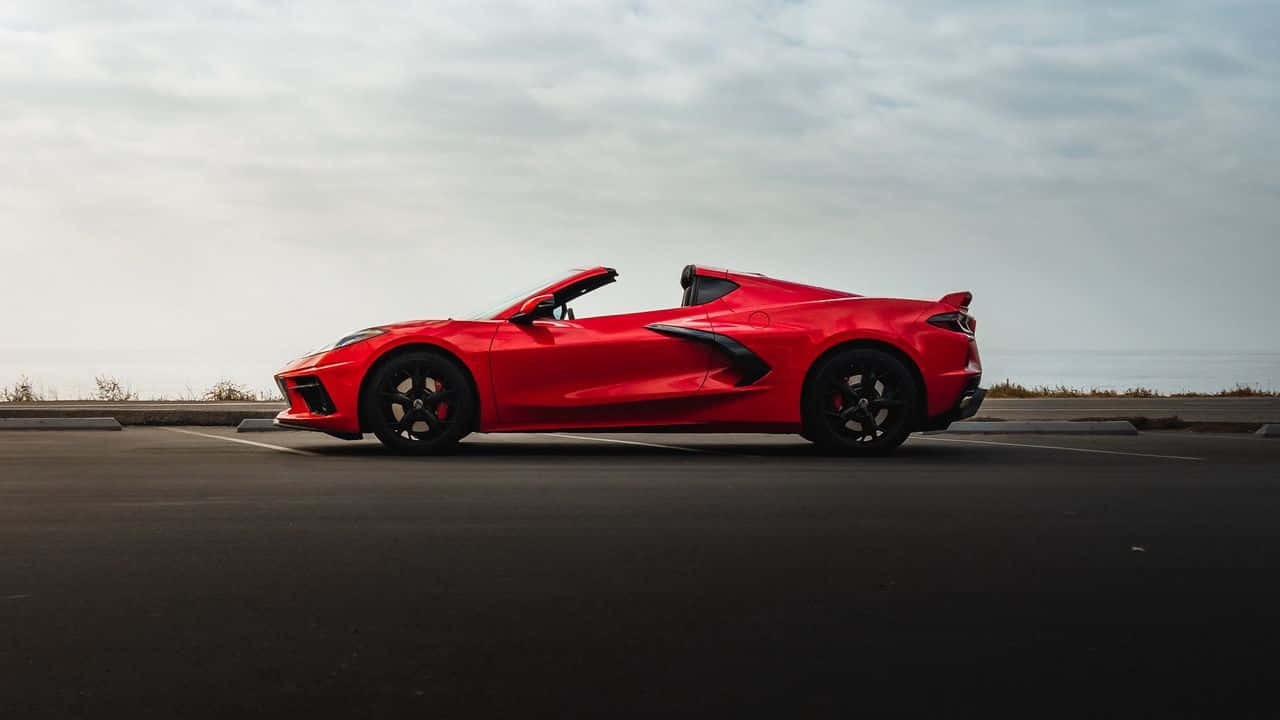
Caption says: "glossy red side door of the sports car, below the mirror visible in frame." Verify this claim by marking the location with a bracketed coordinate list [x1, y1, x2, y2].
[489, 307, 712, 428]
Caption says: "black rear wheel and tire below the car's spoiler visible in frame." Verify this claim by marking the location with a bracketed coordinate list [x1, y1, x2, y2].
[800, 348, 920, 455]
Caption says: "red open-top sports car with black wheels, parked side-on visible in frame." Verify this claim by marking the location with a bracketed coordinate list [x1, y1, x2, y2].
[275, 265, 986, 454]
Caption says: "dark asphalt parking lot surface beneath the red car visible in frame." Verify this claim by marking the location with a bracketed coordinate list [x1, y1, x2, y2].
[0, 428, 1280, 719]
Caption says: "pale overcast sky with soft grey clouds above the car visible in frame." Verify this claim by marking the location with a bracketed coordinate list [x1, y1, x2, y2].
[0, 0, 1280, 393]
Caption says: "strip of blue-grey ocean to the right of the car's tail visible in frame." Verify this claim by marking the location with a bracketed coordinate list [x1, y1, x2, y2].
[979, 343, 1280, 393]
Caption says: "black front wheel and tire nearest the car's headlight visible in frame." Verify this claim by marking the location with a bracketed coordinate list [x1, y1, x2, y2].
[360, 350, 476, 455]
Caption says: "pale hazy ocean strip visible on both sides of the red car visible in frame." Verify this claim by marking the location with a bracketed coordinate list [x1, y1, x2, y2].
[0, 347, 1280, 400]
